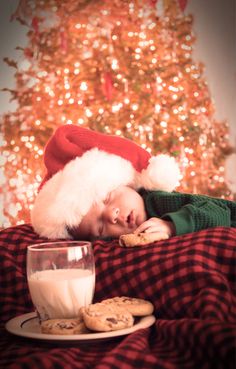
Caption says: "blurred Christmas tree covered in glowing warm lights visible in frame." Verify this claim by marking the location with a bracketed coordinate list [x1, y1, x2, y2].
[2, 0, 231, 226]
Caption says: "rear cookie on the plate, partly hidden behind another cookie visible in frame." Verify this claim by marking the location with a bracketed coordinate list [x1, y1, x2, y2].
[102, 296, 154, 316]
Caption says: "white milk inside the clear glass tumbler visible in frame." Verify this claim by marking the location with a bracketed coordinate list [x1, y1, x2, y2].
[28, 269, 95, 320]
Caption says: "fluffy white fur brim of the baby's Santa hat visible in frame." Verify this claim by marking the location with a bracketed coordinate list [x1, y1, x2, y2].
[31, 148, 135, 239]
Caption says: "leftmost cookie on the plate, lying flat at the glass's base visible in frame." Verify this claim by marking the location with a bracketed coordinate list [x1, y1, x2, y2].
[41, 317, 87, 335]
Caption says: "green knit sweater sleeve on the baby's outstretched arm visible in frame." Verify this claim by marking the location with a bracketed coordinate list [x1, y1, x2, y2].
[161, 200, 231, 235]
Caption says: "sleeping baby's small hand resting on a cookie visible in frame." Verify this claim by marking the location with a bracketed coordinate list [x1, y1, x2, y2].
[134, 218, 175, 237]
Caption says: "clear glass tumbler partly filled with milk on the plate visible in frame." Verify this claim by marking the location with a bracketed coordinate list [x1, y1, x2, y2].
[27, 241, 95, 321]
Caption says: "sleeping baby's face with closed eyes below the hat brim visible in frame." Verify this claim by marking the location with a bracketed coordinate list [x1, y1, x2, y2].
[71, 186, 147, 239]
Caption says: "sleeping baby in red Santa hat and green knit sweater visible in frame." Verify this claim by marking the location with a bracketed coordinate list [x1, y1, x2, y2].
[31, 124, 236, 246]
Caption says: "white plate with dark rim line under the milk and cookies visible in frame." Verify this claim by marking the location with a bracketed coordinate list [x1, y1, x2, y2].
[6, 313, 156, 341]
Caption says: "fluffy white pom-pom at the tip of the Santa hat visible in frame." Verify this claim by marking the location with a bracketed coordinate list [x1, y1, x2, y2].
[139, 154, 181, 192]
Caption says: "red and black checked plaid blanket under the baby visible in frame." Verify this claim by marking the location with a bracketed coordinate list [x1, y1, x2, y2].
[0, 225, 236, 369]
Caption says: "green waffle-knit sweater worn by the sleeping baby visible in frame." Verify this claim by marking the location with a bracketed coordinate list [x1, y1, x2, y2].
[140, 189, 236, 235]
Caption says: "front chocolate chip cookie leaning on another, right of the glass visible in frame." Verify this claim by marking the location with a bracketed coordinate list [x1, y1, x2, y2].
[80, 302, 134, 332]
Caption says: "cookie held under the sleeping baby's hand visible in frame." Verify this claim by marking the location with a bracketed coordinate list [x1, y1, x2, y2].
[119, 232, 169, 247]
